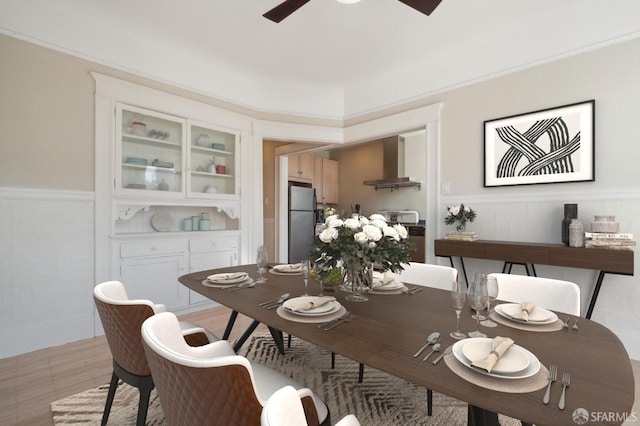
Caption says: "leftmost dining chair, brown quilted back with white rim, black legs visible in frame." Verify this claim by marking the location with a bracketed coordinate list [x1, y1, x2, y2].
[93, 281, 218, 426]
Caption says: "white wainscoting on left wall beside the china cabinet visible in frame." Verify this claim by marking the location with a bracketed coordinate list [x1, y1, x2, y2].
[0, 188, 95, 358]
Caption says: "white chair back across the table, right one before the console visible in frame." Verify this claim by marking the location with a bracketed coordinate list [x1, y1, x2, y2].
[489, 273, 580, 316]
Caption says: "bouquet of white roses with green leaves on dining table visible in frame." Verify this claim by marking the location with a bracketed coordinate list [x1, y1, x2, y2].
[311, 214, 415, 279]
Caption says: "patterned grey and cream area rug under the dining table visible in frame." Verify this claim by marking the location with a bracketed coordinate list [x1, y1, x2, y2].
[51, 333, 520, 426]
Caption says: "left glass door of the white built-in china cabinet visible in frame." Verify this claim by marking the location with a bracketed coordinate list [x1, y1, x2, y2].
[115, 104, 186, 197]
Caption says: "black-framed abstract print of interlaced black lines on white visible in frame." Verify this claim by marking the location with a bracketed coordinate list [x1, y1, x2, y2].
[484, 100, 595, 187]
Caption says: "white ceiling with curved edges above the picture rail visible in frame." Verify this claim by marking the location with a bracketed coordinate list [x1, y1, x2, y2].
[0, 0, 640, 119]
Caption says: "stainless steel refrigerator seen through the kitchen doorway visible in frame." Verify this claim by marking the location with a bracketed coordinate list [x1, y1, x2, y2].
[289, 183, 316, 263]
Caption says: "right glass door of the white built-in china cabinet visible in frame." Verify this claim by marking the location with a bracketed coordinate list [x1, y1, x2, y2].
[187, 121, 240, 198]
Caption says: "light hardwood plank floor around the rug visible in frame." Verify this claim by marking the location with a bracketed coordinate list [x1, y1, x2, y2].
[0, 307, 640, 426]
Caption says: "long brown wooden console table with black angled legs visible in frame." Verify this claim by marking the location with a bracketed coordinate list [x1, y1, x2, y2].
[435, 239, 633, 318]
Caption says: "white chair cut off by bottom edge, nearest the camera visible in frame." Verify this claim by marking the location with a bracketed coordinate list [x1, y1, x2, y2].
[260, 386, 360, 426]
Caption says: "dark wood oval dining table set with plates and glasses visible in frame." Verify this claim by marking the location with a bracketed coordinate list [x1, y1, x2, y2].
[180, 265, 634, 425]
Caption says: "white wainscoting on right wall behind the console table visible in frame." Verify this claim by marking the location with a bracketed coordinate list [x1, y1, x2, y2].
[440, 191, 640, 360]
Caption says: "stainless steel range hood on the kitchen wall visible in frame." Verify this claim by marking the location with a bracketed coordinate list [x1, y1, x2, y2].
[363, 136, 420, 190]
